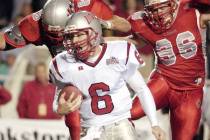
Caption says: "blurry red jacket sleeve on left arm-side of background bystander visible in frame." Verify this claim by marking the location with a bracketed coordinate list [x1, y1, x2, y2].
[17, 84, 29, 118]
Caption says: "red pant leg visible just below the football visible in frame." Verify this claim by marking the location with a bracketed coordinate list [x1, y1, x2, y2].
[65, 110, 80, 140]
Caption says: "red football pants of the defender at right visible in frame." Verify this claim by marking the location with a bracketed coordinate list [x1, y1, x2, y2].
[131, 72, 203, 140]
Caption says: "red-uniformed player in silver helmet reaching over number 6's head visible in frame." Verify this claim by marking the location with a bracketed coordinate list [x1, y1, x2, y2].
[0, 0, 130, 140]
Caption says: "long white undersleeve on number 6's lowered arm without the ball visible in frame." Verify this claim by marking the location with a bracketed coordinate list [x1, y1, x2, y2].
[126, 70, 158, 126]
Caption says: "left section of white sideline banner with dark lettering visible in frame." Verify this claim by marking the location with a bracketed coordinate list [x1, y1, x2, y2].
[0, 119, 69, 140]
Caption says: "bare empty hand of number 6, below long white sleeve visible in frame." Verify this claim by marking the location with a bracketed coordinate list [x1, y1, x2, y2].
[152, 126, 166, 140]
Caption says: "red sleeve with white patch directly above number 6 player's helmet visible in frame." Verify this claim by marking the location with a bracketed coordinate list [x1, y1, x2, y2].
[74, 0, 113, 20]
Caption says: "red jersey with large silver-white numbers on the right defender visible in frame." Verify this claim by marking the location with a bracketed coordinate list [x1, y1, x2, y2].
[129, 1, 205, 90]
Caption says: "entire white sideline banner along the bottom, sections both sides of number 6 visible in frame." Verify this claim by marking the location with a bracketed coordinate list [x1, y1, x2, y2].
[0, 112, 170, 140]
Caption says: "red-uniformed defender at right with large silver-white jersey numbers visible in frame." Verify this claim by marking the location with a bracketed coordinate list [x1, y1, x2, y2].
[129, 0, 209, 140]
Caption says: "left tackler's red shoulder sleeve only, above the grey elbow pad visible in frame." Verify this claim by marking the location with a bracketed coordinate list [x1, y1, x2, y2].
[18, 11, 41, 43]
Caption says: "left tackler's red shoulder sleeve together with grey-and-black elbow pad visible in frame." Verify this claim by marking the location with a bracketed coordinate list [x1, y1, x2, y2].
[4, 11, 41, 50]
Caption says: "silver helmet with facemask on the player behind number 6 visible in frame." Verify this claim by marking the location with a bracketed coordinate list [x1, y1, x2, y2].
[41, 0, 71, 41]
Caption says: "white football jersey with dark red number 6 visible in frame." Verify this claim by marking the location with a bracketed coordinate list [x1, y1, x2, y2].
[50, 41, 144, 127]
